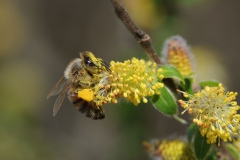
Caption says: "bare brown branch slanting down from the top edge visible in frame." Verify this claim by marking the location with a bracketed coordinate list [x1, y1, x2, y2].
[111, 0, 161, 65]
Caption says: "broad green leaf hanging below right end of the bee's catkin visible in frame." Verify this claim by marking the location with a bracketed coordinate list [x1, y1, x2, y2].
[152, 86, 177, 115]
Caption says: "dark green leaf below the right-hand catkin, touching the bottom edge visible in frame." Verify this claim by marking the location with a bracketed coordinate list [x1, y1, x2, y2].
[193, 131, 211, 160]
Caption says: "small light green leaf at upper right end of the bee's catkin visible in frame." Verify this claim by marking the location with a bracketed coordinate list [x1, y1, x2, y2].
[161, 66, 184, 82]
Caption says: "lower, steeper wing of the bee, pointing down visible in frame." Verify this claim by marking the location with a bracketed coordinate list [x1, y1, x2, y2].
[53, 81, 71, 116]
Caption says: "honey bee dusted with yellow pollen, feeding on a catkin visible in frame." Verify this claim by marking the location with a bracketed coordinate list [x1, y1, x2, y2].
[47, 51, 110, 119]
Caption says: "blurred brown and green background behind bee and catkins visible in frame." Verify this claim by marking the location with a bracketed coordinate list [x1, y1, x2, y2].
[0, 0, 240, 160]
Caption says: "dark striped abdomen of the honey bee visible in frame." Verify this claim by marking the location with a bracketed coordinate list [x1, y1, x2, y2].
[68, 89, 105, 119]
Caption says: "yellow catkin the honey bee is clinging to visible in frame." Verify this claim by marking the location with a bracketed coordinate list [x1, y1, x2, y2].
[94, 58, 164, 105]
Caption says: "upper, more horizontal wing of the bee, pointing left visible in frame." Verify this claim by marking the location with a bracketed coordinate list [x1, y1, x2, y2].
[47, 77, 69, 99]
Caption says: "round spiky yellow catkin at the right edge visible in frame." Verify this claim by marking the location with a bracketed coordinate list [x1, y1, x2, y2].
[179, 84, 240, 145]
